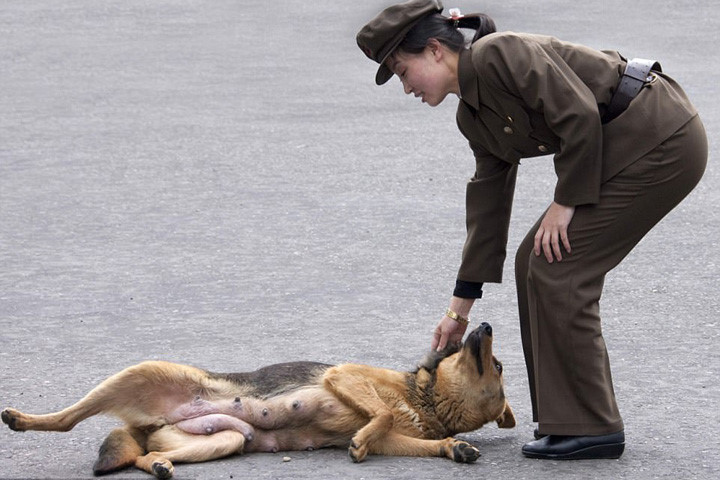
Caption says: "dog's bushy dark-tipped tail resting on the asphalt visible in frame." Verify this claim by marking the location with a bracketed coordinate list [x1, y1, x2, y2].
[93, 427, 147, 475]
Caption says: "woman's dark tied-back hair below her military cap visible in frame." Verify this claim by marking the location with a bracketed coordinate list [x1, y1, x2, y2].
[398, 13, 495, 53]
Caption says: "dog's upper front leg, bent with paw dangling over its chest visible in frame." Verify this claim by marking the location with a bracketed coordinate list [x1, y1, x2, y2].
[324, 367, 393, 462]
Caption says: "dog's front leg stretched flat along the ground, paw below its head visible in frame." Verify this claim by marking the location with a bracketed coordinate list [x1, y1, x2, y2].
[369, 432, 480, 463]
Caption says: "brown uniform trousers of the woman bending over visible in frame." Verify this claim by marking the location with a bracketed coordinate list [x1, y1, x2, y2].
[515, 116, 708, 435]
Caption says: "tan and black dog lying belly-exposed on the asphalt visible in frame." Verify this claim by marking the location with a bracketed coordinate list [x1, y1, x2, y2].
[2, 323, 515, 479]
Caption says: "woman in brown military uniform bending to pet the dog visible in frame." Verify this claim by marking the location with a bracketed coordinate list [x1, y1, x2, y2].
[357, 0, 707, 459]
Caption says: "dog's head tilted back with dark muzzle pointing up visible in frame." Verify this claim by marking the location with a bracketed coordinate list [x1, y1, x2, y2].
[420, 323, 515, 432]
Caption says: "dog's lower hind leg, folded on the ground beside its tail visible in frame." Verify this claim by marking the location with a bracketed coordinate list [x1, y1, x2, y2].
[135, 426, 245, 479]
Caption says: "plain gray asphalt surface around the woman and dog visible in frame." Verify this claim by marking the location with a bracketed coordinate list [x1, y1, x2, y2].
[0, 0, 720, 479]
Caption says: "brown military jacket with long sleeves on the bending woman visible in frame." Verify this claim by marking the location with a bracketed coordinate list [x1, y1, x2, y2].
[457, 32, 697, 282]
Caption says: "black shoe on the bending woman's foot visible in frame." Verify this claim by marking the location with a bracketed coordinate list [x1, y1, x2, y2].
[522, 430, 625, 460]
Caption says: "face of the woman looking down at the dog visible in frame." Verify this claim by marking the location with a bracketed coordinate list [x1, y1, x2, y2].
[388, 44, 457, 107]
